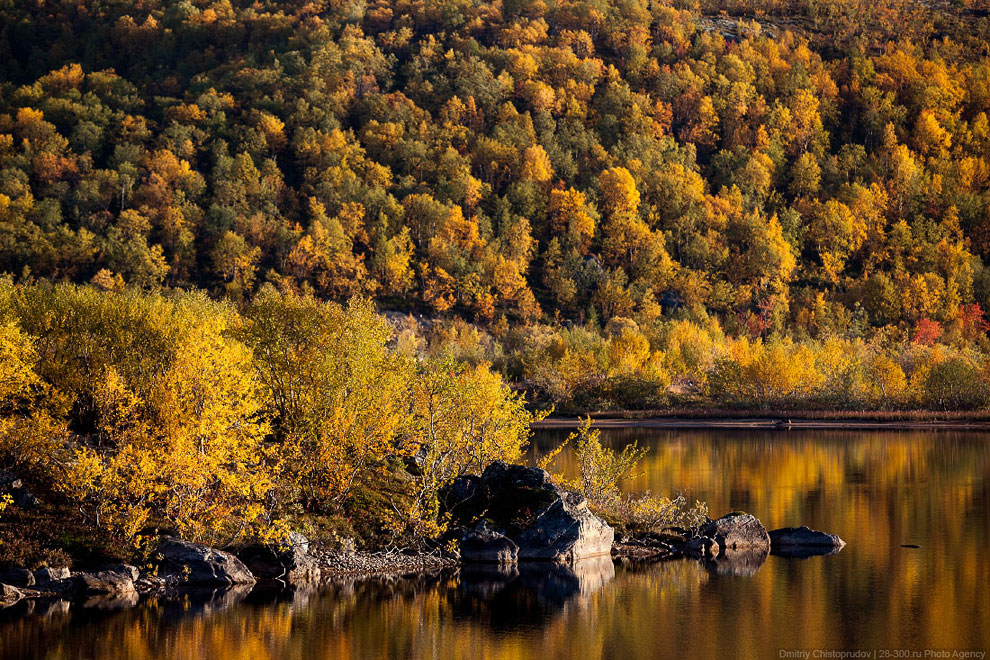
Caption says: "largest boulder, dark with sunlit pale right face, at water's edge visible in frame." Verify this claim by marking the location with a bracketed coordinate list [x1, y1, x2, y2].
[441, 461, 614, 563]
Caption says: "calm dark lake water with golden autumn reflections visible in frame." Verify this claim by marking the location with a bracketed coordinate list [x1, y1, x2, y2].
[0, 430, 990, 660]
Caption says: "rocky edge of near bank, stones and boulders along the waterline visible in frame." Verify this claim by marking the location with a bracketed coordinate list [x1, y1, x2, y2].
[0, 462, 845, 609]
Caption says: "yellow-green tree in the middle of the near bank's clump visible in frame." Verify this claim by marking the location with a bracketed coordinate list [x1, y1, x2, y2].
[239, 289, 411, 509]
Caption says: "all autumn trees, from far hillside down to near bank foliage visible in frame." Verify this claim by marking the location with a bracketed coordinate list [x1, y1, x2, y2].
[0, 0, 990, 556]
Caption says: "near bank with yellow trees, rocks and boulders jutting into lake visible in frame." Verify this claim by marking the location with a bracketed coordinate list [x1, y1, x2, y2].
[0, 279, 884, 601]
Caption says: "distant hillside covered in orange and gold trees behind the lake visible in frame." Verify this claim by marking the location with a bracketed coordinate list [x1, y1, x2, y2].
[0, 0, 990, 407]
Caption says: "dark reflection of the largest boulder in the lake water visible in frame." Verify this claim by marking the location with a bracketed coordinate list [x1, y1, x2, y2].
[451, 557, 615, 628]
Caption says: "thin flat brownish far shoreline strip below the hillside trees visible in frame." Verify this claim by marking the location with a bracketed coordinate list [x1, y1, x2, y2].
[531, 409, 990, 431]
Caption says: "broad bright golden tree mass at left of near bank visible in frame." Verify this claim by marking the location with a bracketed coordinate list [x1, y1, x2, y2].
[10, 286, 270, 542]
